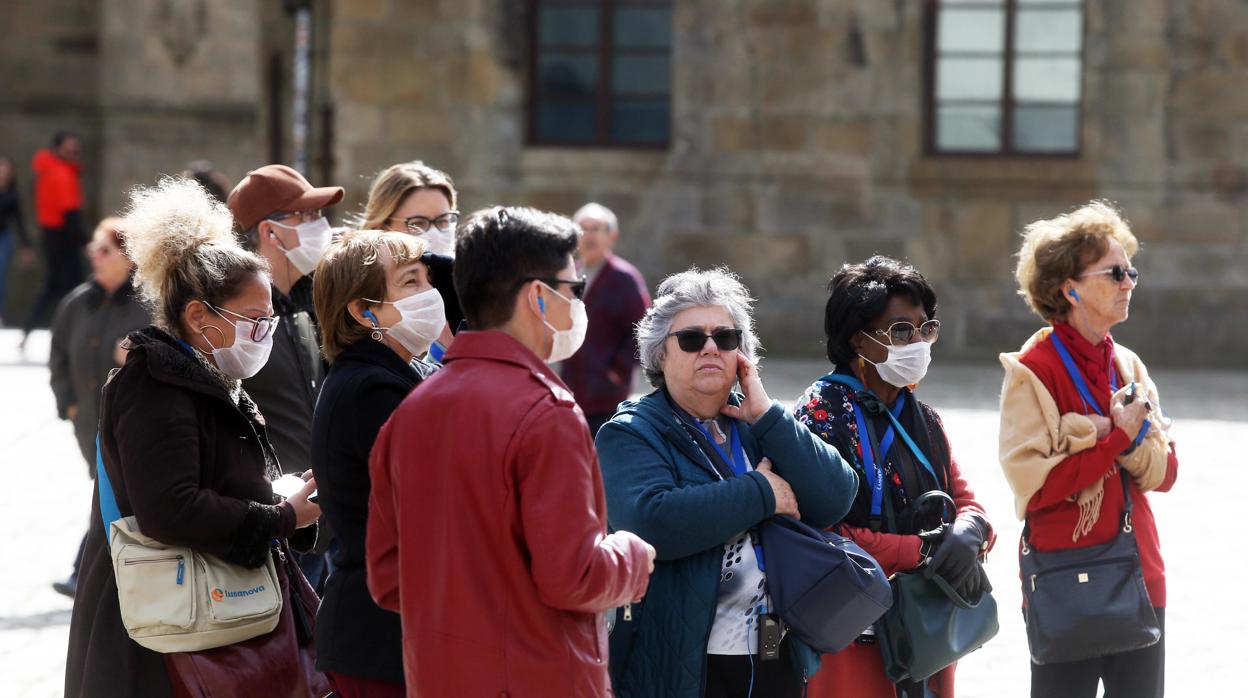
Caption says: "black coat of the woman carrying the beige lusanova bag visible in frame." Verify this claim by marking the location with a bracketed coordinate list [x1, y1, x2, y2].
[65, 327, 314, 698]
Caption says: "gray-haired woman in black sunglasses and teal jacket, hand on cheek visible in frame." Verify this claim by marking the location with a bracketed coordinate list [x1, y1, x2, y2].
[597, 268, 857, 698]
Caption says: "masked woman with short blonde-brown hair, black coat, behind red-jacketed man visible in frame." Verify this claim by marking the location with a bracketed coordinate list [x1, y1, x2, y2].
[305, 230, 446, 698]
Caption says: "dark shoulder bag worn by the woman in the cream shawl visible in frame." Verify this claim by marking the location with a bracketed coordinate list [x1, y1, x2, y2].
[1018, 471, 1161, 664]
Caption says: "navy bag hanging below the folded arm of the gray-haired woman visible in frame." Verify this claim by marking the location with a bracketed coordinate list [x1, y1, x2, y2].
[759, 516, 892, 652]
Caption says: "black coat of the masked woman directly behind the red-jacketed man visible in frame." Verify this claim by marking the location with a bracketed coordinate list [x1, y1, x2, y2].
[312, 338, 433, 683]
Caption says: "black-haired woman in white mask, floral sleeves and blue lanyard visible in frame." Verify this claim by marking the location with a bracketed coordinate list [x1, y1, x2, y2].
[795, 256, 993, 698]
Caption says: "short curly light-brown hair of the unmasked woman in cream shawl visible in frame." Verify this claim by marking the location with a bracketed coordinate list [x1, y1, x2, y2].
[1015, 200, 1139, 322]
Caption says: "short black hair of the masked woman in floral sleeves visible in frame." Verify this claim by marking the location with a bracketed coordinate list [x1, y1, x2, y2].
[824, 255, 936, 366]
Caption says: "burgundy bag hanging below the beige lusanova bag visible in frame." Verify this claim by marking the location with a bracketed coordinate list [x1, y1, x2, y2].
[162, 543, 332, 698]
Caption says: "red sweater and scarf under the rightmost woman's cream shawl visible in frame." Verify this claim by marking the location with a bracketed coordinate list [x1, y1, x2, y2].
[1020, 322, 1178, 608]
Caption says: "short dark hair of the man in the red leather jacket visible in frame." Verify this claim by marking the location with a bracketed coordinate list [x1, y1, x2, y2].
[453, 206, 578, 330]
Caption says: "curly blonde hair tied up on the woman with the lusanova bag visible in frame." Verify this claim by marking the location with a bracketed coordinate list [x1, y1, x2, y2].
[125, 176, 268, 336]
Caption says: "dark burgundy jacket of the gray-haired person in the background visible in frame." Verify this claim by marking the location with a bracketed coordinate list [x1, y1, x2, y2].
[559, 253, 650, 417]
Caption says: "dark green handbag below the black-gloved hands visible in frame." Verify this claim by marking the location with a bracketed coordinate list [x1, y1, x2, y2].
[875, 572, 1000, 682]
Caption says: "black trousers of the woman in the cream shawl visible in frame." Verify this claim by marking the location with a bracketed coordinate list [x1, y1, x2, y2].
[1031, 608, 1166, 698]
